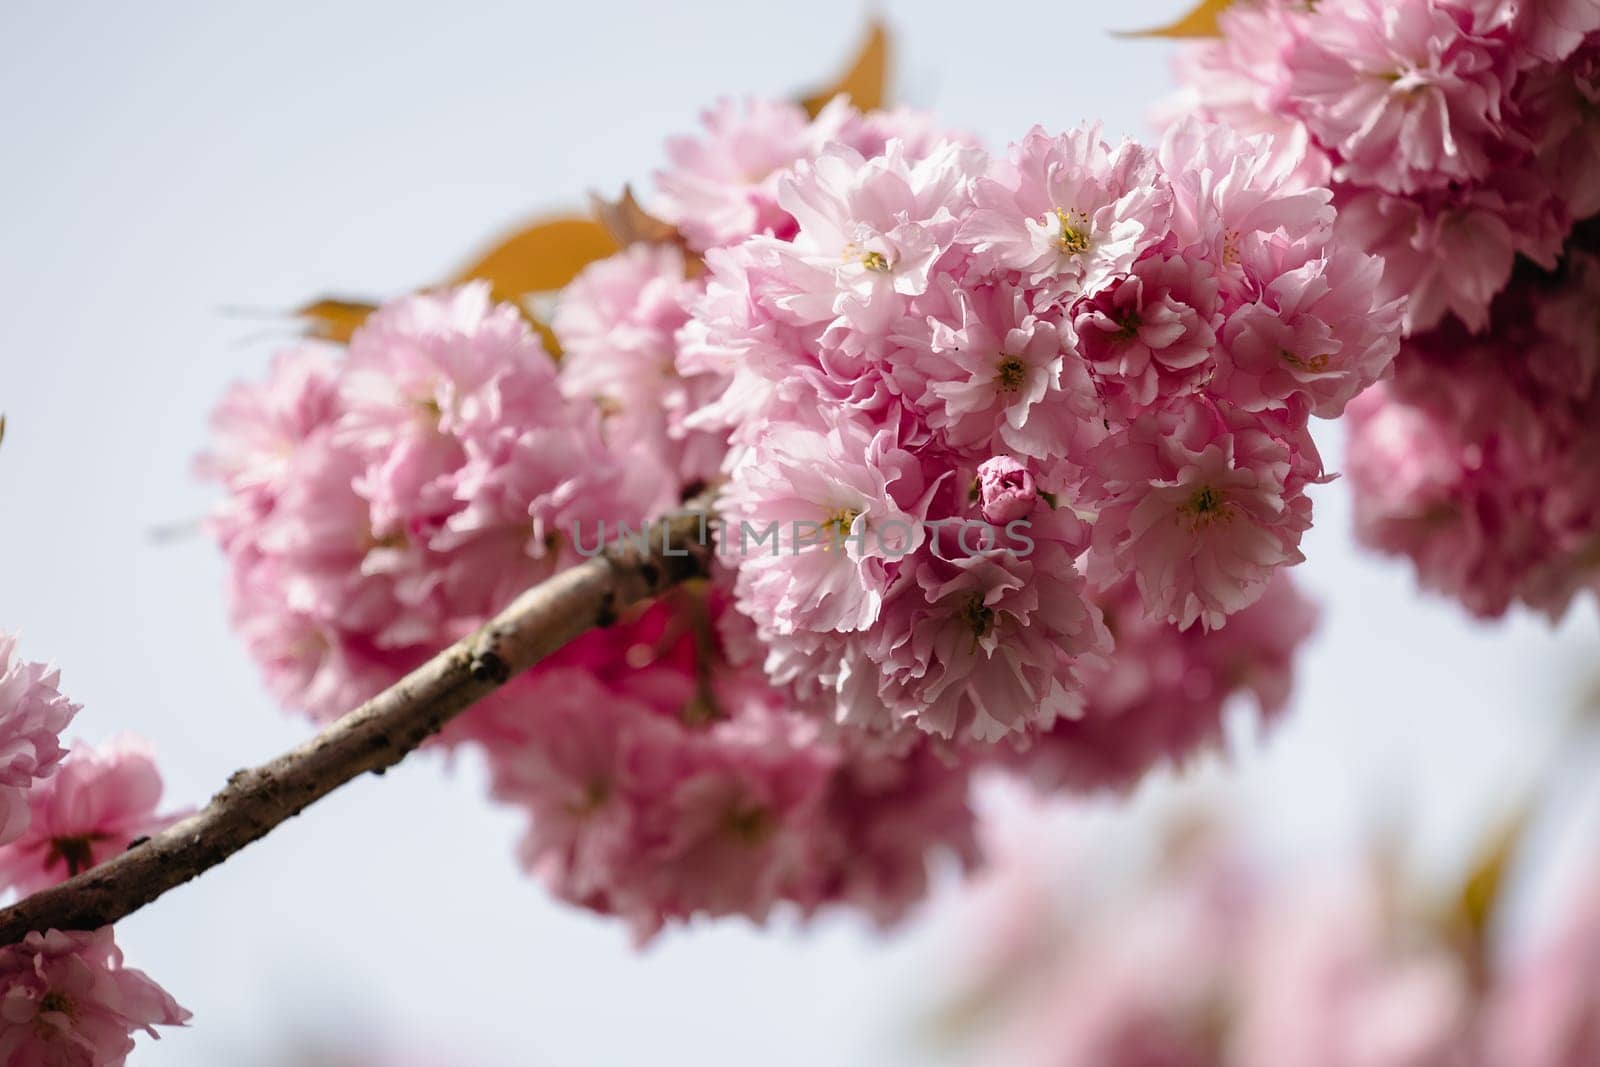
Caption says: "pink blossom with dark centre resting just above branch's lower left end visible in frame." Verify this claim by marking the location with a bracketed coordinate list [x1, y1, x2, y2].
[0, 736, 178, 894]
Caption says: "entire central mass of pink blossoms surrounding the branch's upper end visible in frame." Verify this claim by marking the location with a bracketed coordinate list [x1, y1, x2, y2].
[203, 101, 1350, 936]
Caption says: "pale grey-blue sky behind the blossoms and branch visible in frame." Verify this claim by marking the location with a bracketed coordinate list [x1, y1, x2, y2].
[0, 0, 1600, 1067]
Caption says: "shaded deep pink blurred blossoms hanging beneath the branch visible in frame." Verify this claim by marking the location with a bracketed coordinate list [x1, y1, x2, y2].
[467, 598, 974, 937]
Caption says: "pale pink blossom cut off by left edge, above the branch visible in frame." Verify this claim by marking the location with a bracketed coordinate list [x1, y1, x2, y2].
[0, 630, 80, 845]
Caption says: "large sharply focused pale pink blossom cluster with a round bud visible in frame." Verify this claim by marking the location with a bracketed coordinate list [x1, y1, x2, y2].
[678, 112, 1400, 744]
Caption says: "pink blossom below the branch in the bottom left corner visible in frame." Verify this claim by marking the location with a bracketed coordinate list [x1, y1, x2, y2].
[0, 926, 189, 1067]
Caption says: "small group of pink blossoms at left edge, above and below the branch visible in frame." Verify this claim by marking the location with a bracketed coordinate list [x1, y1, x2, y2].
[0, 632, 189, 1067]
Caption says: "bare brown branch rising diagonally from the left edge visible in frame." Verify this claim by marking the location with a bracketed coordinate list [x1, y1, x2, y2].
[0, 504, 710, 945]
